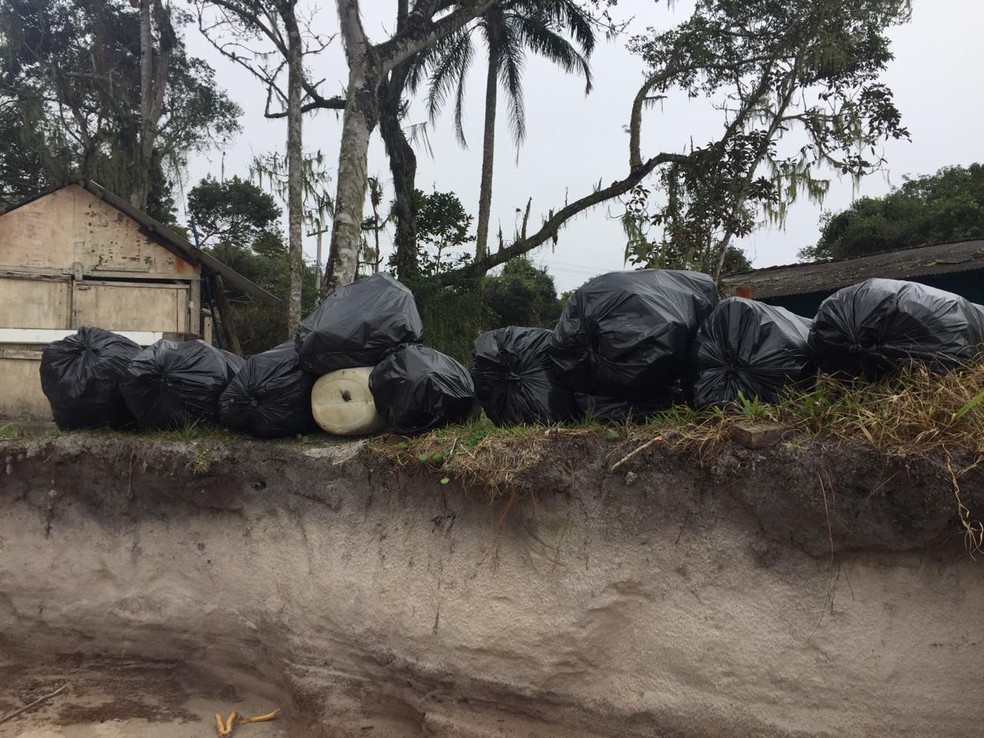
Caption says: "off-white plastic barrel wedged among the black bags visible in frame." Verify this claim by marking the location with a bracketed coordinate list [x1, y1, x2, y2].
[311, 366, 386, 436]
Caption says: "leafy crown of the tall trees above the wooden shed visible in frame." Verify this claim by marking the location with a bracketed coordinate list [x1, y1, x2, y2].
[0, 0, 242, 204]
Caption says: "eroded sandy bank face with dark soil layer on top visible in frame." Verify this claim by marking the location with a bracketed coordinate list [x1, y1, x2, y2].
[0, 434, 984, 738]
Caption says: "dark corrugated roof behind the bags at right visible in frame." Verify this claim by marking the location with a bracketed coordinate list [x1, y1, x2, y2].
[722, 241, 984, 298]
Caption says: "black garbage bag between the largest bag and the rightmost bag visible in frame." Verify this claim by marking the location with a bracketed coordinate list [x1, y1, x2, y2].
[683, 297, 816, 407]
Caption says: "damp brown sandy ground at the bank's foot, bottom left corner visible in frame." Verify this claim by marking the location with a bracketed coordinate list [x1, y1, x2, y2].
[0, 659, 296, 738]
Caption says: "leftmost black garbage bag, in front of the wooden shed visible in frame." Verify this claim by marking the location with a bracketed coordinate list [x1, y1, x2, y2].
[41, 328, 140, 430]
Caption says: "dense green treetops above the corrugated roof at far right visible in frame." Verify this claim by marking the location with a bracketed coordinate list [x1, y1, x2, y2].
[799, 164, 984, 261]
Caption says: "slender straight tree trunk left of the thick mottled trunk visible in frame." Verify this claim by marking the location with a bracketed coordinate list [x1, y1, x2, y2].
[280, 0, 304, 335]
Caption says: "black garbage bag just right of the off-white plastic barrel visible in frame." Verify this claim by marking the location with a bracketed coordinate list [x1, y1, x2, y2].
[369, 345, 477, 435]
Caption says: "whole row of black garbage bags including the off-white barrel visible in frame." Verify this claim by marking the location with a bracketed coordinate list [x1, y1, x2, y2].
[40, 269, 984, 438]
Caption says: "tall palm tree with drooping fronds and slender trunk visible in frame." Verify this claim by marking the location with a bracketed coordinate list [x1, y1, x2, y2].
[408, 0, 595, 259]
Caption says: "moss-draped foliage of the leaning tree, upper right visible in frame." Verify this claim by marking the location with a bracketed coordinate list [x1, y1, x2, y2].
[623, 0, 909, 277]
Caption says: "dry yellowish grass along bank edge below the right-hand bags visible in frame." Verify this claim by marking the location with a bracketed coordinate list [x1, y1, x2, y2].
[371, 363, 984, 554]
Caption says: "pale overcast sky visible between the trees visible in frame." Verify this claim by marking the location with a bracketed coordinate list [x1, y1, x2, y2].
[179, 0, 984, 290]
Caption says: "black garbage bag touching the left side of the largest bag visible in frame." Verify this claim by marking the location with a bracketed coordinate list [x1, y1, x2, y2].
[472, 326, 579, 425]
